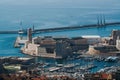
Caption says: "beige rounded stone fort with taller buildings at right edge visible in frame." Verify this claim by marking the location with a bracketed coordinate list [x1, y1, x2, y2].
[88, 30, 120, 56]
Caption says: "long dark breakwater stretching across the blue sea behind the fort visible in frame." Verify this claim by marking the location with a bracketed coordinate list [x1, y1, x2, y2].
[0, 22, 120, 34]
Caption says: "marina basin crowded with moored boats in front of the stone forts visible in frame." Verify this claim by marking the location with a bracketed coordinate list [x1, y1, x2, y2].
[0, 57, 120, 80]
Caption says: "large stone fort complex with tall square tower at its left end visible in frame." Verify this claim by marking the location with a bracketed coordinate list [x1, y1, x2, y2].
[21, 29, 101, 58]
